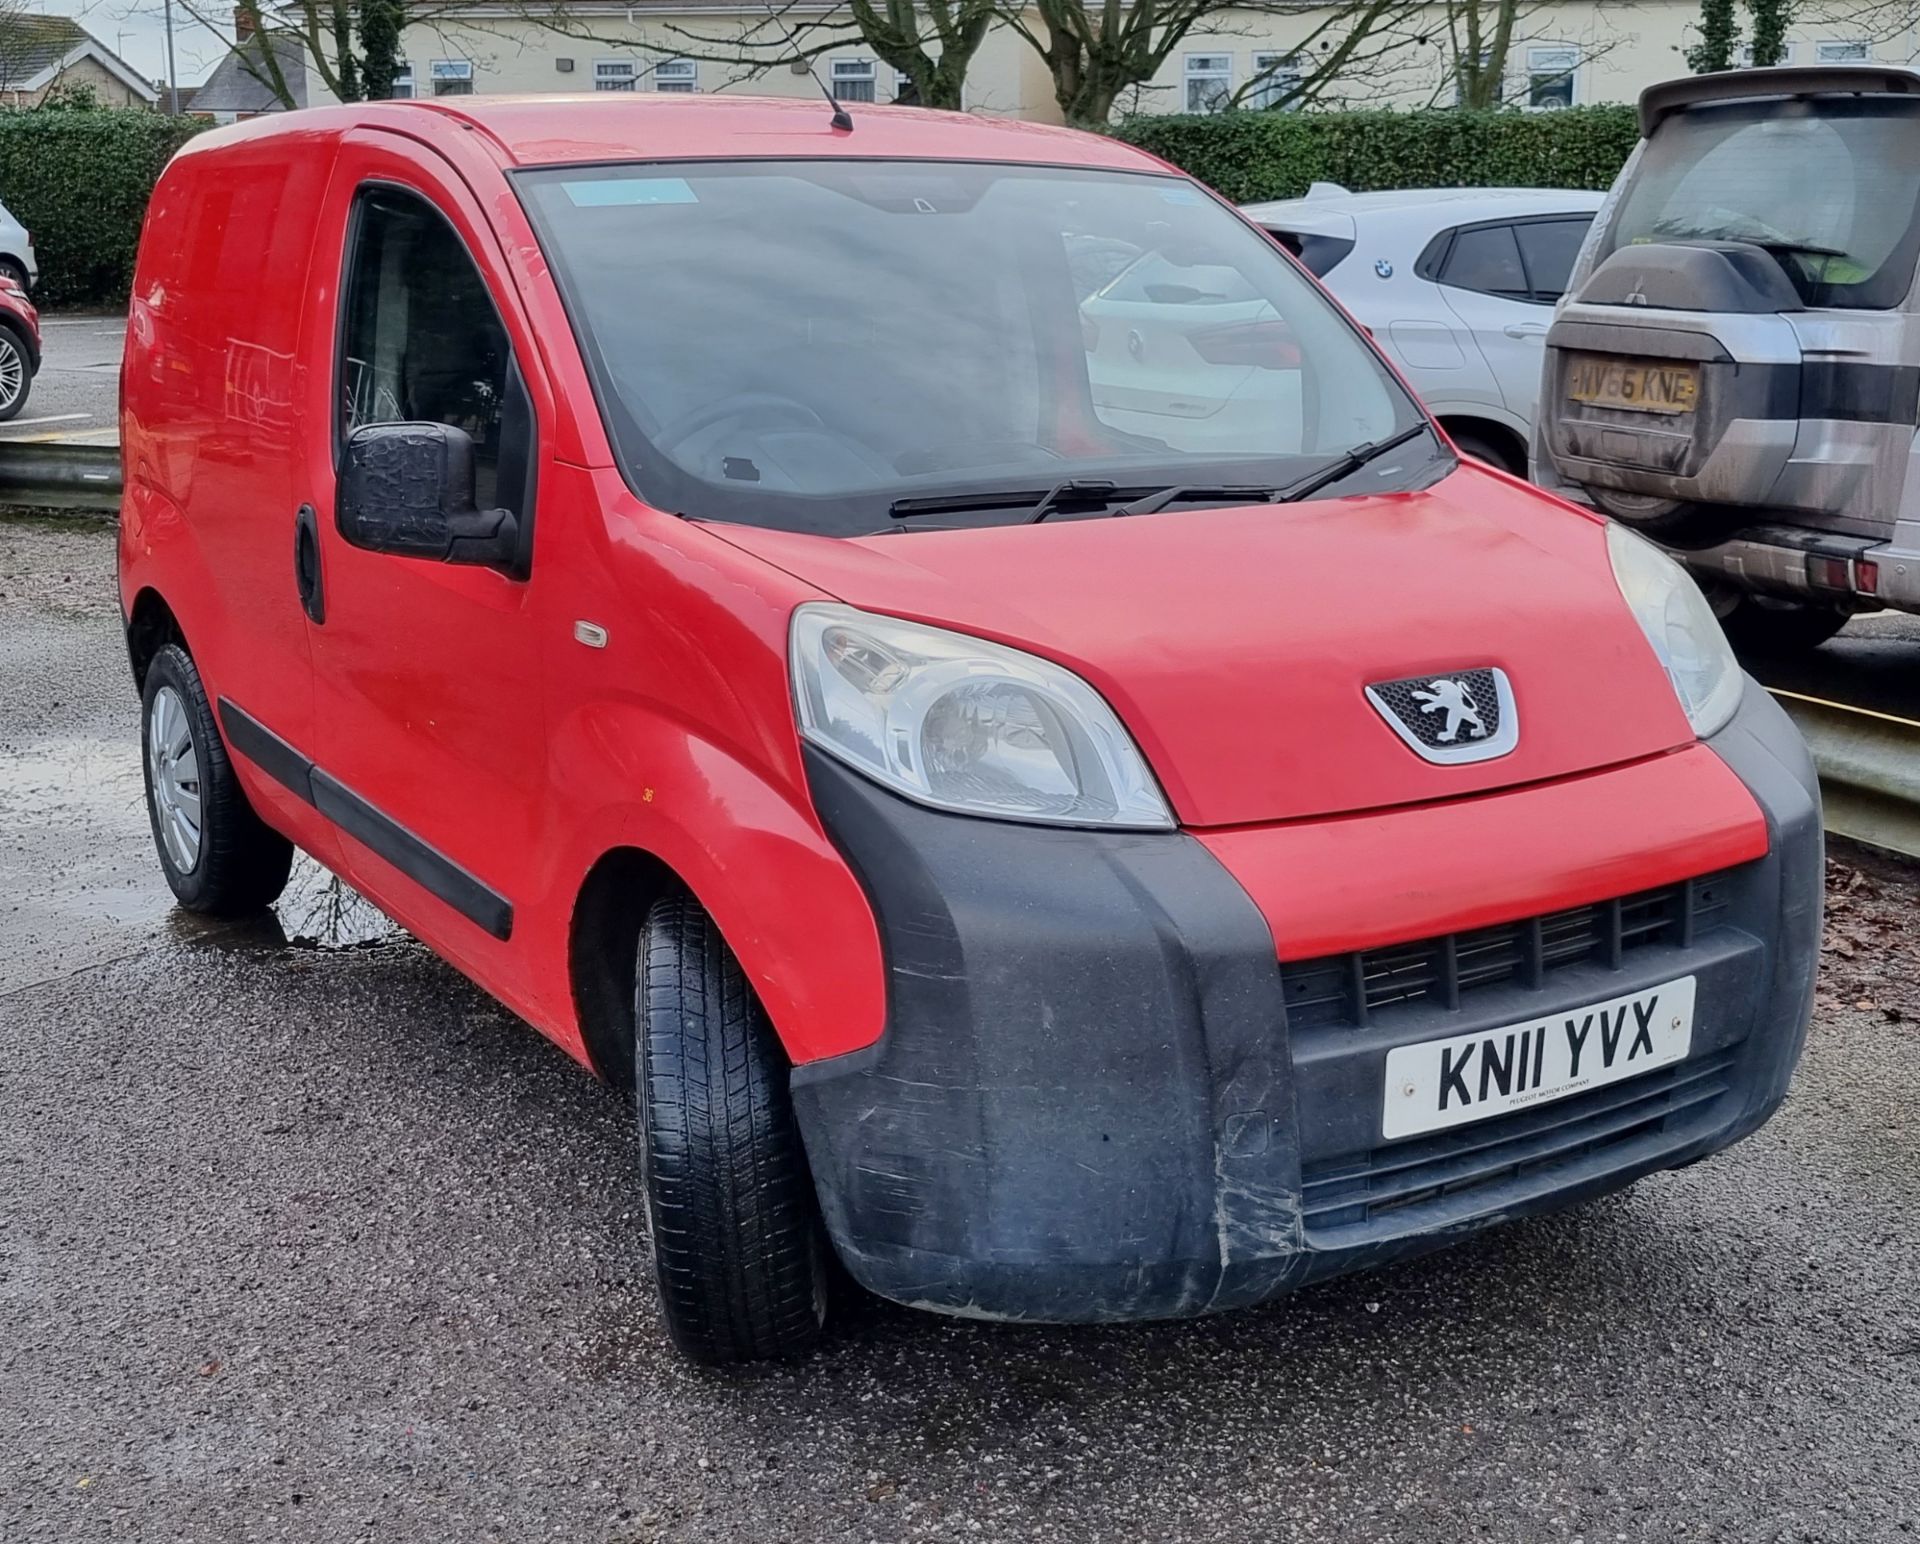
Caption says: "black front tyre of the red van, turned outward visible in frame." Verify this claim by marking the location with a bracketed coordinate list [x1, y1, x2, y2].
[634, 895, 828, 1363]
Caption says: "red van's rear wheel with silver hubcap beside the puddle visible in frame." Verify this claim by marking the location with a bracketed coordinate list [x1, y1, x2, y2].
[140, 643, 294, 916]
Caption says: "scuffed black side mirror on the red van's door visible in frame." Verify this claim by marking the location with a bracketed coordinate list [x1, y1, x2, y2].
[336, 424, 520, 568]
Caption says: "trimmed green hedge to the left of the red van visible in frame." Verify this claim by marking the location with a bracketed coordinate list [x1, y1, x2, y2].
[0, 108, 207, 305]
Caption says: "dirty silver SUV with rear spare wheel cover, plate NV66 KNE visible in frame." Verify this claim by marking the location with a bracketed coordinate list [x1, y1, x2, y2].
[1534, 65, 1920, 651]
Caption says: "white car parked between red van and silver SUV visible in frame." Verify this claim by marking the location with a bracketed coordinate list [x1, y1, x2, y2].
[1244, 182, 1605, 476]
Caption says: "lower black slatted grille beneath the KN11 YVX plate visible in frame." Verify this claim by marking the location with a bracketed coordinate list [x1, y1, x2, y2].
[1302, 1050, 1736, 1242]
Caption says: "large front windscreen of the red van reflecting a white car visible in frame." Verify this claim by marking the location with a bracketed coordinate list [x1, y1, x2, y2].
[518, 159, 1444, 536]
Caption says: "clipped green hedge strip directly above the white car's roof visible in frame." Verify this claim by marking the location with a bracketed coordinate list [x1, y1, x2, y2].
[1114, 106, 1640, 204]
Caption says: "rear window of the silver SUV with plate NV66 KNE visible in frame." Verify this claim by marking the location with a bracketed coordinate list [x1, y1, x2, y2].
[1603, 96, 1920, 311]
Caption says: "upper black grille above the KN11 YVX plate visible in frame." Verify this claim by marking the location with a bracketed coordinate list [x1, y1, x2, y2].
[1281, 874, 1728, 1031]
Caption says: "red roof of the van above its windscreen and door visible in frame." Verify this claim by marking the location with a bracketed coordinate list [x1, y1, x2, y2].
[188, 92, 1167, 171]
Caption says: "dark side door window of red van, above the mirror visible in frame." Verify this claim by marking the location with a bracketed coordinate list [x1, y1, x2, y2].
[338, 188, 513, 509]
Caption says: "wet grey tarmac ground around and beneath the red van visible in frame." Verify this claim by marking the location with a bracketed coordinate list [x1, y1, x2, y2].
[0, 522, 1920, 1544]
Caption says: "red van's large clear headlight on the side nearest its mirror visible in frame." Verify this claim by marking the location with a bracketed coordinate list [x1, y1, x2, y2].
[791, 605, 1173, 832]
